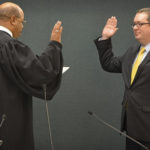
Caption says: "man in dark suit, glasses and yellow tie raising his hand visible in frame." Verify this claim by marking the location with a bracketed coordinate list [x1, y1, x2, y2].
[95, 8, 150, 150]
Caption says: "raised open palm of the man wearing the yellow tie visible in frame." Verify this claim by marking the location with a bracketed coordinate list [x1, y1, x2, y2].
[102, 16, 118, 40]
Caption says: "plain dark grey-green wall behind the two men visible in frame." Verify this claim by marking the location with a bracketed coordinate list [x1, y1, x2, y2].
[1, 0, 150, 150]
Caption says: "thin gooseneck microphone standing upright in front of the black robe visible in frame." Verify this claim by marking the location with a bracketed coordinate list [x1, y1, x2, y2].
[42, 84, 54, 150]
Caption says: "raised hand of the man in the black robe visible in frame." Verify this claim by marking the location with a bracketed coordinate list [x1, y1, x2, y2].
[50, 21, 63, 43]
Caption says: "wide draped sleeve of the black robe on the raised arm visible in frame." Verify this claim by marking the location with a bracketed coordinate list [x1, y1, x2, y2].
[0, 39, 63, 100]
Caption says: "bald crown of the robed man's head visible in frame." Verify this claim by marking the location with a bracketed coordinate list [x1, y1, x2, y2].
[0, 2, 23, 19]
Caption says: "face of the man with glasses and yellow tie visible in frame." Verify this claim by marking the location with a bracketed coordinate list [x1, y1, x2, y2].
[133, 13, 150, 45]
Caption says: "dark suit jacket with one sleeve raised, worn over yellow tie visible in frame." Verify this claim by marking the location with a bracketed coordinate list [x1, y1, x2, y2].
[95, 39, 150, 141]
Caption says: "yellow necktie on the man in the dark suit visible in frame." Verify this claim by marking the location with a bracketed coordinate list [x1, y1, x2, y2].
[131, 47, 145, 84]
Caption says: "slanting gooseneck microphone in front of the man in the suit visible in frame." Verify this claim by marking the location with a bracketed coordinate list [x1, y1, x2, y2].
[88, 111, 149, 150]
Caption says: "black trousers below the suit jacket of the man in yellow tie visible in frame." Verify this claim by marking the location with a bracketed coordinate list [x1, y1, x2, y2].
[126, 138, 150, 150]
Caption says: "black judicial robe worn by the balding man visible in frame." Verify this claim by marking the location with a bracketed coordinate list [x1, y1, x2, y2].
[0, 31, 63, 150]
